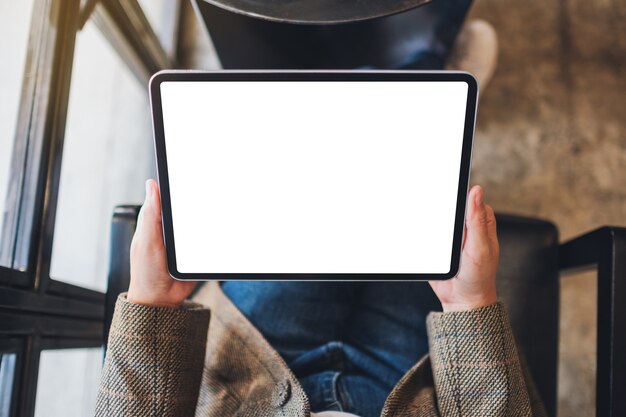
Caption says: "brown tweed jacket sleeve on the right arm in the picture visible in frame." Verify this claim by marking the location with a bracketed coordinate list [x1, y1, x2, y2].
[427, 303, 543, 417]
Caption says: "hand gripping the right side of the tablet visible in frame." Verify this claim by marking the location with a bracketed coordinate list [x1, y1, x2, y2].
[430, 186, 499, 311]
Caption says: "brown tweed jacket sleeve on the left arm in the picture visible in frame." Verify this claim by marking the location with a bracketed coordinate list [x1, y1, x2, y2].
[95, 294, 209, 417]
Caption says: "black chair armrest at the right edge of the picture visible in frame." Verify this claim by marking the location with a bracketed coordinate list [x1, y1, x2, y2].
[559, 226, 626, 417]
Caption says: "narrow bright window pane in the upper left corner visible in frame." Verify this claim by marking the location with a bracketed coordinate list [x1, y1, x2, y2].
[0, 0, 34, 266]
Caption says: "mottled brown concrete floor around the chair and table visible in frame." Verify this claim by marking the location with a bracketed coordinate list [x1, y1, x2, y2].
[182, 0, 626, 417]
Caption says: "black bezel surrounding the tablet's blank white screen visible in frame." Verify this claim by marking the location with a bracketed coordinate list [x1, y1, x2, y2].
[149, 70, 478, 281]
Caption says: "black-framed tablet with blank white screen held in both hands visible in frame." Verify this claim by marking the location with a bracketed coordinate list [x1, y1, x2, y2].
[150, 71, 477, 280]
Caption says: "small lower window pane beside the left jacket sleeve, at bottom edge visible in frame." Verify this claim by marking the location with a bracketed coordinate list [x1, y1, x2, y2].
[35, 348, 102, 417]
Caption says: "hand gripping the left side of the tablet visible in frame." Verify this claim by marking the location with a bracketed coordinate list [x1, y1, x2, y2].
[127, 180, 196, 308]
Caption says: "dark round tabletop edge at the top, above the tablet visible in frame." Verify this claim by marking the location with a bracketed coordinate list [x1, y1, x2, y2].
[204, 0, 431, 24]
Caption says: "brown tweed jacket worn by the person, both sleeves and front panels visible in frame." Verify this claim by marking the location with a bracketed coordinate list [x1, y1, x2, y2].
[96, 283, 545, 417]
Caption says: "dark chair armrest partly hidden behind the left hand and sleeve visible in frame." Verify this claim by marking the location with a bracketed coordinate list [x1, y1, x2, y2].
[104, 205, 141, 350]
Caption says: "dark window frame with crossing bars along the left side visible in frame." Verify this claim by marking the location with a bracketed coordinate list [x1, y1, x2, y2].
[0, 0, 176, 417]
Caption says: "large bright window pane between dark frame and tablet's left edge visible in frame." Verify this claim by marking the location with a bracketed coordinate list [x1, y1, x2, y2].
[50, 21, 155, 291]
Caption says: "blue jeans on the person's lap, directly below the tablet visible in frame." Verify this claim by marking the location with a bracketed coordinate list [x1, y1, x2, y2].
[222, 281, 441, 417]
